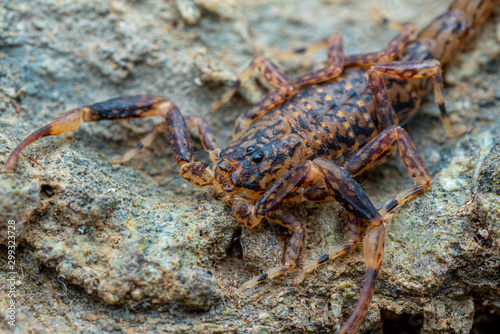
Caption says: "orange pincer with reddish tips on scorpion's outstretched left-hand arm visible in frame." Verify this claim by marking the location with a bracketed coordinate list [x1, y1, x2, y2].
[5, 108, 83, 170]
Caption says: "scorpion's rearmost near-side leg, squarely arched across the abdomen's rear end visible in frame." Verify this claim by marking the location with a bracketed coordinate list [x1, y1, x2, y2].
[368, 60, 466, 137]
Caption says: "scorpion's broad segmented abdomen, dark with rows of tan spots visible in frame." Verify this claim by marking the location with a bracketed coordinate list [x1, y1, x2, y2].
[258, 68, 420, 166]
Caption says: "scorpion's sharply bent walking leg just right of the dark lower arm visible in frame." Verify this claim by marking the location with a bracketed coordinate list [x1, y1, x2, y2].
[344, 126, 432, 216]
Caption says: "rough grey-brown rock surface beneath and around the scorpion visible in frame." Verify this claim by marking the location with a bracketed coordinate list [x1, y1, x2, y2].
[0, 0, 500, 333]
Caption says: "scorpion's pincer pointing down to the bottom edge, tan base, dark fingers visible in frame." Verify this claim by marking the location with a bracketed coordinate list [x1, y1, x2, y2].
[339, 224, 385, 334]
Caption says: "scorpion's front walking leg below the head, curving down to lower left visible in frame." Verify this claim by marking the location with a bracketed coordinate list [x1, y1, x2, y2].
[236, 210, 306, 293]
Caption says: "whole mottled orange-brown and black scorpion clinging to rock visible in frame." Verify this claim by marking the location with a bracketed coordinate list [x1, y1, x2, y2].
[5, 0, 498, 333]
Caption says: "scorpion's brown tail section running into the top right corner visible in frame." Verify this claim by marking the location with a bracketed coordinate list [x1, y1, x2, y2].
[412, 0, 498, 64]
